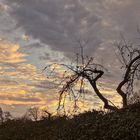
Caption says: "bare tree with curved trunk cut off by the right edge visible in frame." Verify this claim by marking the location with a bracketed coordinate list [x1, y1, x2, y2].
[116, 39, 140, 107]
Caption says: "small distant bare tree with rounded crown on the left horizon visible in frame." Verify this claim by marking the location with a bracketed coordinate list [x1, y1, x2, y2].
[27, 107, 40, 121]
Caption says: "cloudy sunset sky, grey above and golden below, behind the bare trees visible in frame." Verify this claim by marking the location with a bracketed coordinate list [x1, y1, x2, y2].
[0, 0, 140, 116]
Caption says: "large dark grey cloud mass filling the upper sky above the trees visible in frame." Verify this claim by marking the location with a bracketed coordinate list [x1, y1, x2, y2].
[2, 0, 140, 61]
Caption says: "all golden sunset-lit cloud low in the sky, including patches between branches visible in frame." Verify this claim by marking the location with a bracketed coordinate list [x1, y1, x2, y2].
[0, 41, 122, 116]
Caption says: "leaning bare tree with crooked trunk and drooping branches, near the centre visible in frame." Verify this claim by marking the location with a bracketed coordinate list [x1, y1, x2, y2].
[44, 41, 117, 110]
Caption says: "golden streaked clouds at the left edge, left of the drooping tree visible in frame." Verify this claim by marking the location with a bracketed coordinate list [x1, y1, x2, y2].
[0, 41, 57, 113]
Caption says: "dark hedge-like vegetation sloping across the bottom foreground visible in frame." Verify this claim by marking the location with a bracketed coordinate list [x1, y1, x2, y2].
[0, 103, 140, 140]
